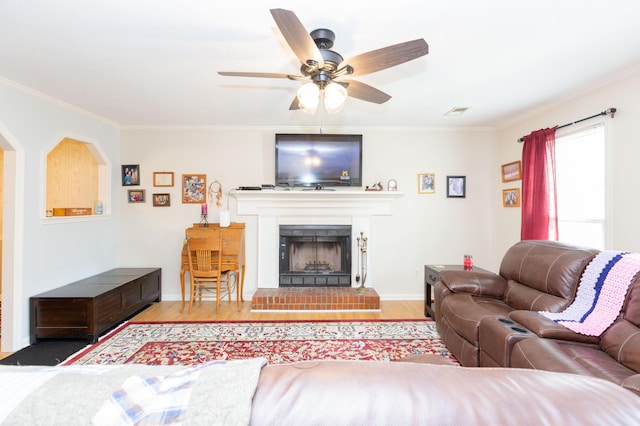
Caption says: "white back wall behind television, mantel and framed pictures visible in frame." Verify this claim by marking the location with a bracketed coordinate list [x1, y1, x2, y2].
[116, 128, 499, 300]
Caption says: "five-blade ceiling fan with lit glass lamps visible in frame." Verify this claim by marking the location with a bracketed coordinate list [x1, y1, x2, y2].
[218, 9, 429, 113]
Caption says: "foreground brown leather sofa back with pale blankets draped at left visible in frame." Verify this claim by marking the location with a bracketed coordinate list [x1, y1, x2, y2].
[0, 355, 640, 426]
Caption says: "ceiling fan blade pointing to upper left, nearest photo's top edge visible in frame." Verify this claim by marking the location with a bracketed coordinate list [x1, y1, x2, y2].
[271, 9, 324, 68]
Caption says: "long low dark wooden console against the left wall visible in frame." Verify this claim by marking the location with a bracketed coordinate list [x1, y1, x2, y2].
[29, 268, 162, 344]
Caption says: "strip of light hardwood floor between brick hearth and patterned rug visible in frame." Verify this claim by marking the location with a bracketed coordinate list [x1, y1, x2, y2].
[131, 300, 424, 321]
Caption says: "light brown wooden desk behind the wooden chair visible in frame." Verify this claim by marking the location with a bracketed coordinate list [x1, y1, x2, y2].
[180, 222, 245, 310]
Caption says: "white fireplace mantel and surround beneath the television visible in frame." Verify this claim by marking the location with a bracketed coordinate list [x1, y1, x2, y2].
[231, 189, 403, 288]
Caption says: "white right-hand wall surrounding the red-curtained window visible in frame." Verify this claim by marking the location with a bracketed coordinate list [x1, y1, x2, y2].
[497, 69, 640, 253]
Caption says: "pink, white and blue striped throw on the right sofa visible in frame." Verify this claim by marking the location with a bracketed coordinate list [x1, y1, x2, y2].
[539, 250, 640, 336]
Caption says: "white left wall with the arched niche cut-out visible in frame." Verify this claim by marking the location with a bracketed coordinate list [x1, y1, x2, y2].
[0, 80, 120, 351]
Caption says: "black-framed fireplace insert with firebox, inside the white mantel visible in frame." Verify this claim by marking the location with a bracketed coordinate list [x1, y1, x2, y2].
[279, 225, 351, 287]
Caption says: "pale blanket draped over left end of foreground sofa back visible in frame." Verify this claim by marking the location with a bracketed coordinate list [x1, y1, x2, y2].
[0, 358, 267, 426]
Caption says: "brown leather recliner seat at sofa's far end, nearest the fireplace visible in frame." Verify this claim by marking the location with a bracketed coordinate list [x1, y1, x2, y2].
[434, 241, 596, 366]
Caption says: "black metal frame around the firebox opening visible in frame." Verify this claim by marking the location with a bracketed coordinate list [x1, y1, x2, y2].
[278, 225, 351, 287]
